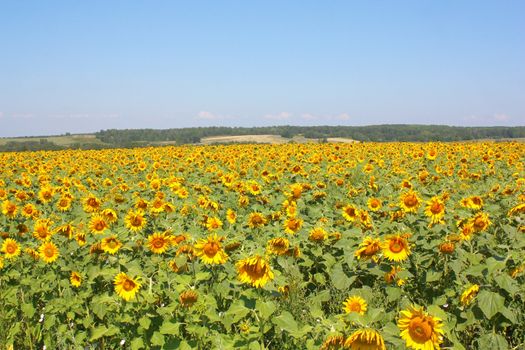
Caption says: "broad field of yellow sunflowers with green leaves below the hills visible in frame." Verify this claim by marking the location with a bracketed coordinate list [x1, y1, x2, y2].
[0, 142, 525, 350]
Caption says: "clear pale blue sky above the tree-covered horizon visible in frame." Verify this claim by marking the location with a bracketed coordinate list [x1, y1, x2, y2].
[0, 0, 525, 136]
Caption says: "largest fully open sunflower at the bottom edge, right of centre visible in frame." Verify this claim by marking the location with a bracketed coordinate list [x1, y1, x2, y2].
[397, 306, 443, 350]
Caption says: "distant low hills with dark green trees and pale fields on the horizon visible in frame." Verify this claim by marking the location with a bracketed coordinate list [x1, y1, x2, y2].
[0, 124, 525, 151]
